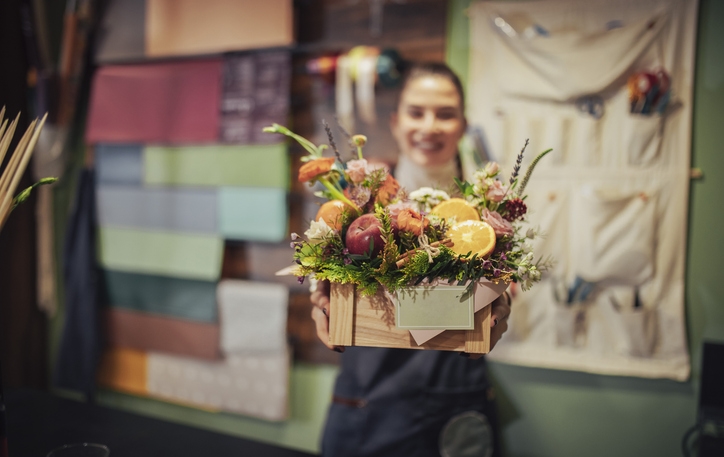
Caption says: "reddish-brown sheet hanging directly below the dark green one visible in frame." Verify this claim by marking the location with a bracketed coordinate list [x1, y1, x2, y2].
[106, 307, 221, 360]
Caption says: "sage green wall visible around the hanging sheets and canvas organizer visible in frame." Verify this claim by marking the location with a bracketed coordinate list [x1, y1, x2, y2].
[52, 0, 724, 457]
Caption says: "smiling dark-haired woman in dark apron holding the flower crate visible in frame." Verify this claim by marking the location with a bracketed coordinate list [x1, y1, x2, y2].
[311, 64, 510, 457]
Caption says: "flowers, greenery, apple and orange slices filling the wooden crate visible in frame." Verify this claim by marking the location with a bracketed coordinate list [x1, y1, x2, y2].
[264, 124, 552, 295]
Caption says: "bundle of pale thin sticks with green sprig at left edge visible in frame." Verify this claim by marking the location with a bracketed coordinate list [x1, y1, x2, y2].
[0, 107, 57, 230]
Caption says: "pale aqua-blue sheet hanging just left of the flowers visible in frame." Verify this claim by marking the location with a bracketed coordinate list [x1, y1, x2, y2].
[219, 187, 288, 242]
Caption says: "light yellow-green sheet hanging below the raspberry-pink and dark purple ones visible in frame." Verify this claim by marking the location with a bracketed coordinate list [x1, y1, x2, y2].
[143, 143, 289, 189]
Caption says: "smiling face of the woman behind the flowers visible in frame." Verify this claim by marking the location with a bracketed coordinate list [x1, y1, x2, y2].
[391, 75, 466, 167]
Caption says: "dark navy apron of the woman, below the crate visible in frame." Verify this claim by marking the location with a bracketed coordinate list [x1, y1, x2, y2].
[322, 348, 499, 457]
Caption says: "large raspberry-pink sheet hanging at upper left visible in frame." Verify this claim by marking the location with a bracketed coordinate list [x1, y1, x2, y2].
[86, 59, 222, 144]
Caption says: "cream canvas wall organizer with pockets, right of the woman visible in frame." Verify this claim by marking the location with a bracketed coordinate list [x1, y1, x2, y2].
[468, 0, 698, 380]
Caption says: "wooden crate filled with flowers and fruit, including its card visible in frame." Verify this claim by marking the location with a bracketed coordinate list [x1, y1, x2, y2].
[264, 124, 551, 353]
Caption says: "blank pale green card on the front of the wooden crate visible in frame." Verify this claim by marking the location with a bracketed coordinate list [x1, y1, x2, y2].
[395, 286, 475, 330]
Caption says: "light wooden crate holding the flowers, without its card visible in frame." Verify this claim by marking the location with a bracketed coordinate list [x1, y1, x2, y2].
[329, 283, 492, 354]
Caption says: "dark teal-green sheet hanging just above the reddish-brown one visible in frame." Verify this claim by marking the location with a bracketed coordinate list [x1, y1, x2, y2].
[103, 270, 218, 323]
